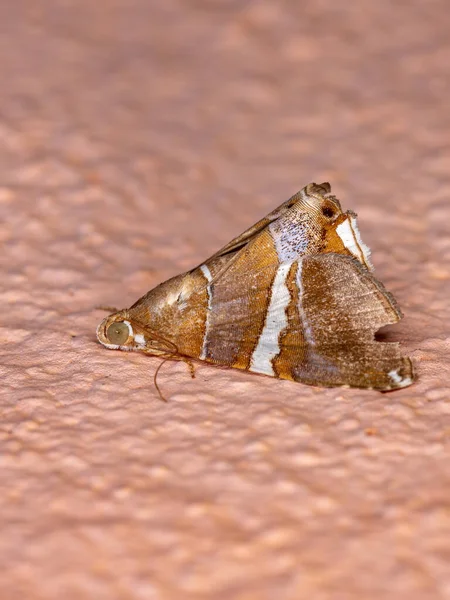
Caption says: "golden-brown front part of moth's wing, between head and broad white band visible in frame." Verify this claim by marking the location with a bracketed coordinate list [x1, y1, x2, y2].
[116, 226, 279, 369]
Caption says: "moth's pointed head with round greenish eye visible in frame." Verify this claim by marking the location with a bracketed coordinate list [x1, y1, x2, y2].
[97, 309, 177, 356]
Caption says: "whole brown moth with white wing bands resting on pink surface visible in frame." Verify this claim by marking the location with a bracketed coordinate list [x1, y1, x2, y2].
[97, 183, 414, 391]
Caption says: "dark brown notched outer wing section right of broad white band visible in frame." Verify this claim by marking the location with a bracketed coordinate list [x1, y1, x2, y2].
[273, 254, 414, 391]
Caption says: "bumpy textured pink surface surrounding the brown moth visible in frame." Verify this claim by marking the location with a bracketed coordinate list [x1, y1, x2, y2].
[0, 0, 450, 600]
